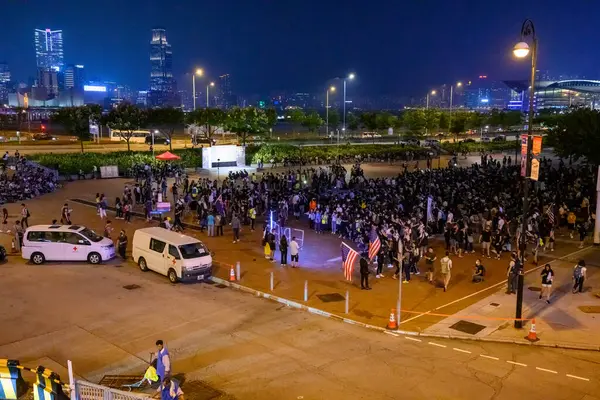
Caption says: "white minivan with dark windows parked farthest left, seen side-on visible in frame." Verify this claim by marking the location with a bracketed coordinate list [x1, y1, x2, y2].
[21, 225, 115, 265]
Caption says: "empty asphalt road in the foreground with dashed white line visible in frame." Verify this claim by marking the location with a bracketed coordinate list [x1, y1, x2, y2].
[0, 257, 600, 400]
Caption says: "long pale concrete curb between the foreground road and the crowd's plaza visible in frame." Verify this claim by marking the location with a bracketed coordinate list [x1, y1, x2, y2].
[211, 276, 600, 351]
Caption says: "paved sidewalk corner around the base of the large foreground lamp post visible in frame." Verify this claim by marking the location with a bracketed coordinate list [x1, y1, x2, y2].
[424, 248, 600, 350]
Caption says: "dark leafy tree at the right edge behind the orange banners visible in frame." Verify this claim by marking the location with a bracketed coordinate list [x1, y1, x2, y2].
[547, 108, 600, 165]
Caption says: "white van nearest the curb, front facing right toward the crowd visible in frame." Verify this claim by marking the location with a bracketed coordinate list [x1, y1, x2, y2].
[133, 227, 212, 283]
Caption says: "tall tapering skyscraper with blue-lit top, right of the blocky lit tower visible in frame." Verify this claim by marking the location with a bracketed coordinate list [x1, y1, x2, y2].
[148, 28, 179, 107]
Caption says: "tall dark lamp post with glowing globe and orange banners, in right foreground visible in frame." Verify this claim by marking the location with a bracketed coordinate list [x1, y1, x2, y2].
[513, 19, 538, 329]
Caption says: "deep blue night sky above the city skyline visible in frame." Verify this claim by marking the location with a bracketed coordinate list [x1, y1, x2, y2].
[0, 0, 600, 96]
